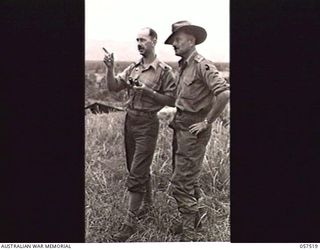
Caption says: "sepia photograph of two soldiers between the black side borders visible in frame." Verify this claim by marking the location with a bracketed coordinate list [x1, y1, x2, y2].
[85, 0, 231, 243]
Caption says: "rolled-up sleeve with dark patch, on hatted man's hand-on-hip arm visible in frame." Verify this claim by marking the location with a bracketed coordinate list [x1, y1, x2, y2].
[200, 60, 230, 96]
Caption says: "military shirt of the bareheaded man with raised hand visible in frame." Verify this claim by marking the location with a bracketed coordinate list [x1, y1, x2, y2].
[116, 58, 176, 112]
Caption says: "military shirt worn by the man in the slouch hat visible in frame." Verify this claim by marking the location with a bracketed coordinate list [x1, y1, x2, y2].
[176, 51, 229, 112]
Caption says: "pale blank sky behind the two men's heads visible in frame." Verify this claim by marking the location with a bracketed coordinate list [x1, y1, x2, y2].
[85, 0, 230, 62]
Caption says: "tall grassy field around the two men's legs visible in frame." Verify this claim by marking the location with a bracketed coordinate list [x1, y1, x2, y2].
[85, 108, 230, 242]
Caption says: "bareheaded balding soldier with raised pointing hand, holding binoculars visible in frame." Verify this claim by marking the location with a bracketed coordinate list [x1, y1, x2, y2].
[104, 28, 176, 242]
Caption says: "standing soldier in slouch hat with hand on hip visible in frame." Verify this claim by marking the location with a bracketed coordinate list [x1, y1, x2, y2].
[165, 21, 229, 241]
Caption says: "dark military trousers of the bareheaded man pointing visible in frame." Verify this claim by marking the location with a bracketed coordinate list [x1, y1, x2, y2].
[124, 110, 159, 193]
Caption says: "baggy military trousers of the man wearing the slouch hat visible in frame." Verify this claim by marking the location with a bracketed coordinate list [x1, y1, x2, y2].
[171, 112, 211, 214]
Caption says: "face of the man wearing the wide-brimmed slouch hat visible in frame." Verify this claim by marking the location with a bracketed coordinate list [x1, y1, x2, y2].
[172, 32, 194, 56]
